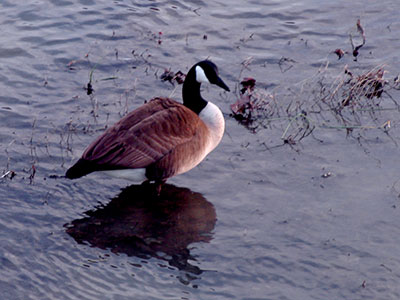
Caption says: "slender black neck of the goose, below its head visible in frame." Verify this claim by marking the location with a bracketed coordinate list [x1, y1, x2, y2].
[182, 68, 207, 114]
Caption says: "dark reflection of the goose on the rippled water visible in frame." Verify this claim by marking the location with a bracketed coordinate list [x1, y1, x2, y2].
[65, 184, 216, 275]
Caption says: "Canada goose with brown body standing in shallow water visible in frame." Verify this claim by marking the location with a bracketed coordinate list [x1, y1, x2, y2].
[65, 60, 229, 189]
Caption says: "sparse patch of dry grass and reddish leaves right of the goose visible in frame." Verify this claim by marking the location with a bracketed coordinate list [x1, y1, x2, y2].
[231, 64, 400, 144]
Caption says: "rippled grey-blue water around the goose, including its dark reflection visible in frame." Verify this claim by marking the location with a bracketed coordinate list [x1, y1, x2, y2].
[0, 0, 400, 299]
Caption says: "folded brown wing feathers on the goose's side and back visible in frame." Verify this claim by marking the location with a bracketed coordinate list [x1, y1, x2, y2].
[82, 98, 203, 170]
